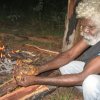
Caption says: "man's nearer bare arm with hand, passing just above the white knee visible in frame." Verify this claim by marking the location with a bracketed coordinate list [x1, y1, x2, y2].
[18, 56, 100, 86]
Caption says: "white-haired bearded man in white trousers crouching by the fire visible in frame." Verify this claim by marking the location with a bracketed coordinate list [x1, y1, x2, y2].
[17, 0, 100, 100]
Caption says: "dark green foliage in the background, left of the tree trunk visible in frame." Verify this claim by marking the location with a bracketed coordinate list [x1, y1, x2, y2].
[0, 0, 67, 36]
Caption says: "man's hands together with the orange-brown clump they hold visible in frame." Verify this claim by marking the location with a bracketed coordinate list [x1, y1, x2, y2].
[13, 60, 39, 86]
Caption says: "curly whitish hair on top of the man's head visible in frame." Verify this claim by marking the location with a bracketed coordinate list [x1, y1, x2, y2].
[76, 0, 100, 27]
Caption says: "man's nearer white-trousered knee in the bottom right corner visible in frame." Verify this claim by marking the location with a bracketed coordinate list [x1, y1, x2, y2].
[82, 74, 100, 100]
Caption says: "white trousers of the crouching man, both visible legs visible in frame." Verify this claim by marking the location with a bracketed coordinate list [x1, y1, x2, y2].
[59, 61, 100, 100]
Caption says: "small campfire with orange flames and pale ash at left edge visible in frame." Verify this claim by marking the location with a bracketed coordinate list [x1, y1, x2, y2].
[0, 42, 31, 75]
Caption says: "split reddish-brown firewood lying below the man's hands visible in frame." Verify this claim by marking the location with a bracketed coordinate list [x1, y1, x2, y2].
[0, 70, 57, 100]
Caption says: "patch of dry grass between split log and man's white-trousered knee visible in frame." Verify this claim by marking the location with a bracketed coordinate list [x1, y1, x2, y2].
[42, 87, 83, 100]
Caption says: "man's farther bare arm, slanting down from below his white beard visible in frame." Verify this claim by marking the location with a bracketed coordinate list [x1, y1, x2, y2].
[39, 39, 89, 73]
